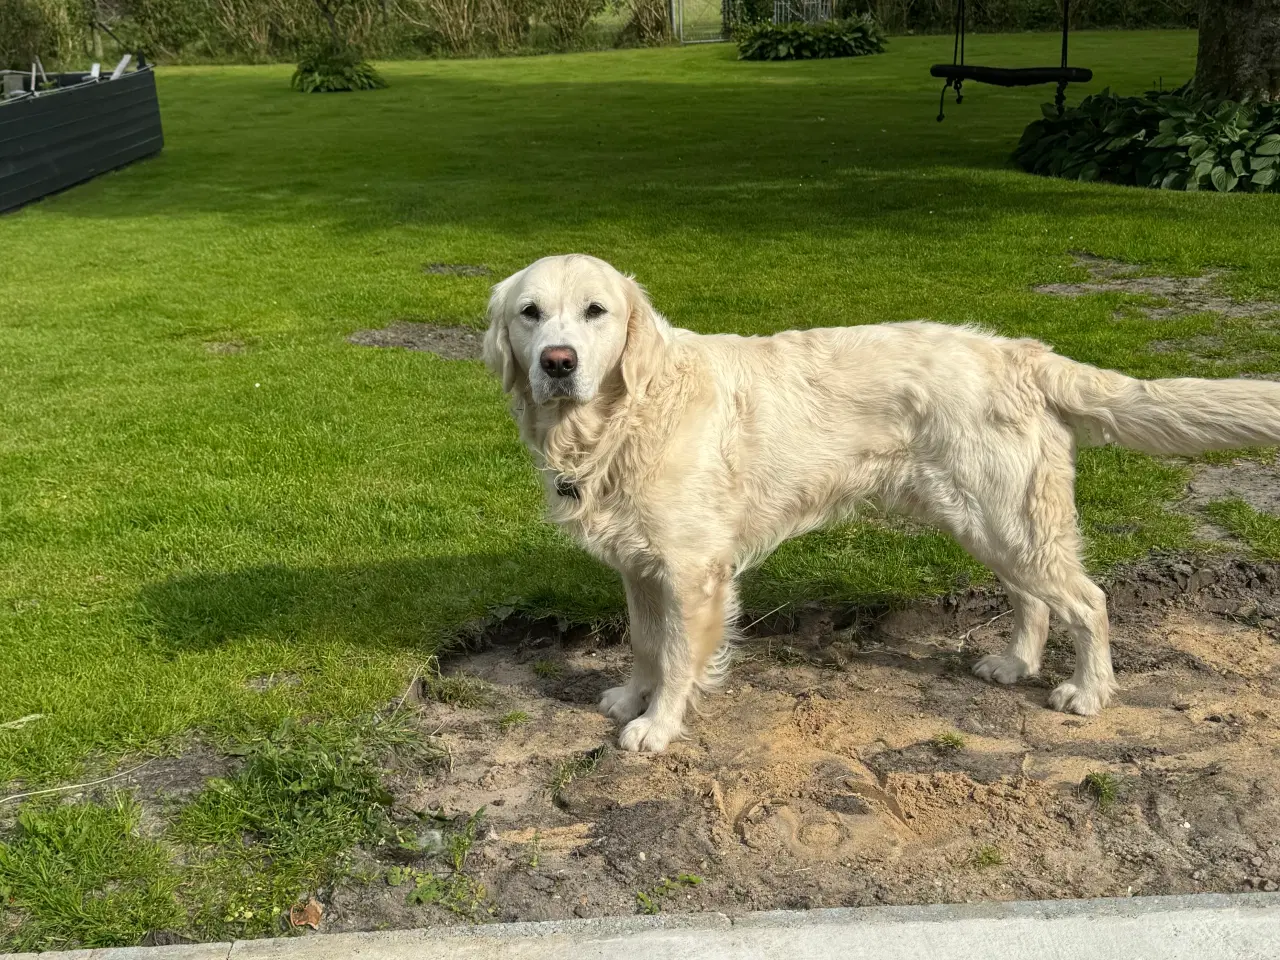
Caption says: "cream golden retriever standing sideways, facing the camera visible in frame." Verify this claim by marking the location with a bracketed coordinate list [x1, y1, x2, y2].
[484, 255, 1280, 751]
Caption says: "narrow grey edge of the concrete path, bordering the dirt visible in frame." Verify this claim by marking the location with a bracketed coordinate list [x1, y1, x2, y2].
[0, 893, 1280, 960]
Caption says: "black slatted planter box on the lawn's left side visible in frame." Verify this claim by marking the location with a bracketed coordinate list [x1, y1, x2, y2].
[0, 69, 164, 211]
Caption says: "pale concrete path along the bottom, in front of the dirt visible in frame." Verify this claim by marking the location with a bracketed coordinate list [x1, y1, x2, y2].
[10, 893, 1280, 960]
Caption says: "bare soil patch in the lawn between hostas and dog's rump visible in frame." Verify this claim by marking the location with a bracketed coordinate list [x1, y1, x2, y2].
[1034, 251, 1280, 320]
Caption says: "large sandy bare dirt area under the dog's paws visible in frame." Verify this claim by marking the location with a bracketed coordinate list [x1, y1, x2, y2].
[314, 557, 1280, 931]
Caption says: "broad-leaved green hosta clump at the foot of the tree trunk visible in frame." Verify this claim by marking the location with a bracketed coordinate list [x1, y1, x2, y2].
[1014, 87, 1280, 193]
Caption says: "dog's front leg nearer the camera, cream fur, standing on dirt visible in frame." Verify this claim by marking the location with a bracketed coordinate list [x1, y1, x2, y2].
[618, 568, 732, 753]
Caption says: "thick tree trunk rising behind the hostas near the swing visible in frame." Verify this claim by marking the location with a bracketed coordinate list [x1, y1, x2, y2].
[1196, 0, 1280, 100]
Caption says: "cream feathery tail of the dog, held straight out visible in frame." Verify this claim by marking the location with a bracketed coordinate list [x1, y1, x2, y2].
[1038, 353, 1280, 456]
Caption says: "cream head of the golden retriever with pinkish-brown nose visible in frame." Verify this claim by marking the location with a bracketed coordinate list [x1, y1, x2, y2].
[484, 253, 666, 403]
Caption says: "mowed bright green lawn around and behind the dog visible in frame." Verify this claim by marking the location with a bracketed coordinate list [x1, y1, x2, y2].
[0, 32, 1280, 787]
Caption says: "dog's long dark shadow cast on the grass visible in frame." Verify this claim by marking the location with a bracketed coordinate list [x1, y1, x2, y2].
[137, 547, 623, 655]
